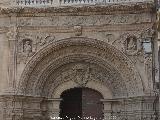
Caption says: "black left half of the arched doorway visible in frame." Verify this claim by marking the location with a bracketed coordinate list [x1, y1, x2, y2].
[60, 88, 82, 120]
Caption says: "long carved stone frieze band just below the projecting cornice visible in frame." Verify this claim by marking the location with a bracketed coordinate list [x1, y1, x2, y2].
[17, 13, 152, 27]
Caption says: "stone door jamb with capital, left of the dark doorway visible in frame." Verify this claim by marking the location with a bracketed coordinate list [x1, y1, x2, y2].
[47, 98, 62, 120]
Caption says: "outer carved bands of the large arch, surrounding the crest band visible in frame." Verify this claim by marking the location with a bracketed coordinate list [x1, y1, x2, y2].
[17, 37, 143, 96]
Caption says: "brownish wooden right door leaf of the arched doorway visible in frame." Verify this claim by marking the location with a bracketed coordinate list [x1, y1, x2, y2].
[82, 88, 103, 120]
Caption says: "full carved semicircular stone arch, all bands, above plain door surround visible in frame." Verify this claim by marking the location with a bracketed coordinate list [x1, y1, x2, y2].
[19, 38, 143, 97]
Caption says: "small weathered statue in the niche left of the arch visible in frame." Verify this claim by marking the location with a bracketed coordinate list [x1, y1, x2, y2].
[23, 39, 32, 57]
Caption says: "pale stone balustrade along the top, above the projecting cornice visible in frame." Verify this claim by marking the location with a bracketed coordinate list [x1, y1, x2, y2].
[16, 0, 153, 6]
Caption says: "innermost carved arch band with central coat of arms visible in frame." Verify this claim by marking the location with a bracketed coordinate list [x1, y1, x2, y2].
[37, 61, 127, 97]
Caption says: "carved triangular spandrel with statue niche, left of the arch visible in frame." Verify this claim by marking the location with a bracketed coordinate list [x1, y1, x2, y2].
[17, 33, 55, 64]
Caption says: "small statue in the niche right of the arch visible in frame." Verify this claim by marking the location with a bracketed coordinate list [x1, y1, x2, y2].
[127, 36, 137, 50]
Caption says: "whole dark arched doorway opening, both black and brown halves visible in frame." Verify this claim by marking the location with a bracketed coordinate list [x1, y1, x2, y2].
[60, 88, 103, 120]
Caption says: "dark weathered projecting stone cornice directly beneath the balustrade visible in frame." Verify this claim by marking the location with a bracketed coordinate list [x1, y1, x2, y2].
[0, 2, 155, 16]
